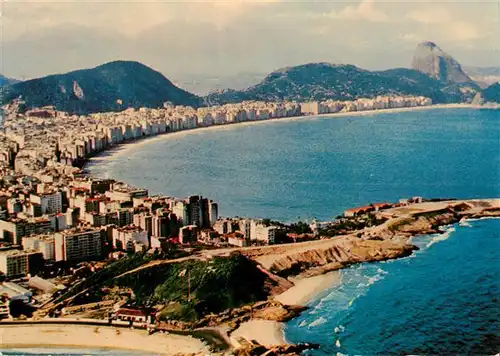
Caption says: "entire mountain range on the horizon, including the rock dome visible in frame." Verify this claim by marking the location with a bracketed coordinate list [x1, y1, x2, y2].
[0, 42, 495, 114]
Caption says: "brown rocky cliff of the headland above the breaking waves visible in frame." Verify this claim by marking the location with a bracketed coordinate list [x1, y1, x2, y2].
[253, 205, 472, 277]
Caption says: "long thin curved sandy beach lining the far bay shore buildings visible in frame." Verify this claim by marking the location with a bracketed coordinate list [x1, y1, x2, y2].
[89, 104, 487, 164]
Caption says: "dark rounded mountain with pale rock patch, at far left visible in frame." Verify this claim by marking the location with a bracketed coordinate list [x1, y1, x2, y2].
[0, 61, 202, 114]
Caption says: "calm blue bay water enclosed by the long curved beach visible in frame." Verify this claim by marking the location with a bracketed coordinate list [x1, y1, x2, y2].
[90, 109, 500, 220]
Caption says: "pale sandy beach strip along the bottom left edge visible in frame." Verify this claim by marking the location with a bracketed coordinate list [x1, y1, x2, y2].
[0, 325, 210, 355]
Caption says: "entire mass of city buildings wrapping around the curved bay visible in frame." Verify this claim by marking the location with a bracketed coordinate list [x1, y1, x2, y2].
[0, 97, 431, 278]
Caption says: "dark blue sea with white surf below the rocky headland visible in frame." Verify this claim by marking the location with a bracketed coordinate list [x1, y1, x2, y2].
[286, 219, 500, 355]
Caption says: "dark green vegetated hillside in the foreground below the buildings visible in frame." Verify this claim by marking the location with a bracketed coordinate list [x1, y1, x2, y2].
[58, 254, 269, 321]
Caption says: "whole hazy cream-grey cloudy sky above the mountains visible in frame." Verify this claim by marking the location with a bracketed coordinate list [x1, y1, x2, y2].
[0, 0, 500, 79]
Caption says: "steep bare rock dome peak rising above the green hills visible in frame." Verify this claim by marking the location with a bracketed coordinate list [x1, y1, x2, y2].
[412, 42, 474, 84]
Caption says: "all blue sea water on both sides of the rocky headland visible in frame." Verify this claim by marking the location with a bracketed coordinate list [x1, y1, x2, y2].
[89, 109, 500, 355]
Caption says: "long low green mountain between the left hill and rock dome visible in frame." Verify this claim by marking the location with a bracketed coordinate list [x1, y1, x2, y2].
[206, 63, 479, 104]
